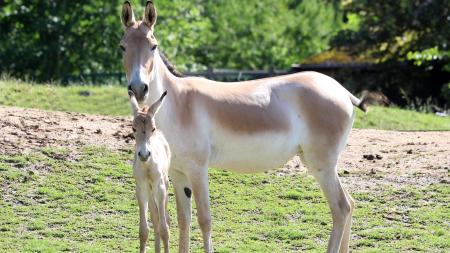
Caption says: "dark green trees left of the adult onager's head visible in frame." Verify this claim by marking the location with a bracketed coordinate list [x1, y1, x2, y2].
[0, 0, 122, 80]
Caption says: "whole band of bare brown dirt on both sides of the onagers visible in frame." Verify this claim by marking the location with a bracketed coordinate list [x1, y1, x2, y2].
[0, 107, 450, 192]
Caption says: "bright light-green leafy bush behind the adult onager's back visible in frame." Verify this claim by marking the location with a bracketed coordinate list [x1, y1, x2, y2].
[199, 0, 340, 69]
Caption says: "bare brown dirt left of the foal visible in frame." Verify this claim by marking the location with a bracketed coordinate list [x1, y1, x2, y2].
[0, 107, 133, 154]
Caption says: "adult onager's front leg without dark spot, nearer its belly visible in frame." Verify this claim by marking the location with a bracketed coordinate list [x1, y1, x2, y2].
[190, 167, 213, 253]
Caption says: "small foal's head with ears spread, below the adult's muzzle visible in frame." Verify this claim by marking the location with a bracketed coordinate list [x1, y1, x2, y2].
[128, 91, 167, 162]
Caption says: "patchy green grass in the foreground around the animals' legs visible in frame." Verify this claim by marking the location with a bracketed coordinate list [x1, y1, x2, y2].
[0, 147, 450, 252]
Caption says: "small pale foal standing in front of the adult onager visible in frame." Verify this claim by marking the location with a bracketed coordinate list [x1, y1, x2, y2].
[129, 91, 171, 253]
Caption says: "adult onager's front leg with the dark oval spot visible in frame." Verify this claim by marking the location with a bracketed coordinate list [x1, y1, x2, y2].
[170, 169, 192, 253]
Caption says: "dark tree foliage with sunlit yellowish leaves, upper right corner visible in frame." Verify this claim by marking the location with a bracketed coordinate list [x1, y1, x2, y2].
[335, 0, 450, 64]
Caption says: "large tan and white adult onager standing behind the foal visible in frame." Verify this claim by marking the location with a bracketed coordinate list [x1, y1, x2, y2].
[120, 1, 368, 252]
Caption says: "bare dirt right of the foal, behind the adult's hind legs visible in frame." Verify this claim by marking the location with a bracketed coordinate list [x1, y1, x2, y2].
[280, 129, 450, 192]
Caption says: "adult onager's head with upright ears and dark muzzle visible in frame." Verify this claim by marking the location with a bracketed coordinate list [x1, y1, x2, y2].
[120, 1, 158, 102]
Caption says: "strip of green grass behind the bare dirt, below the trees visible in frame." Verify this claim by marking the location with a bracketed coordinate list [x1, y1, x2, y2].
[0, 80, 450, 130]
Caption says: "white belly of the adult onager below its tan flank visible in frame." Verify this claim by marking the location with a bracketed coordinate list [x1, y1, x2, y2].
[209, 121, 300, 173]
